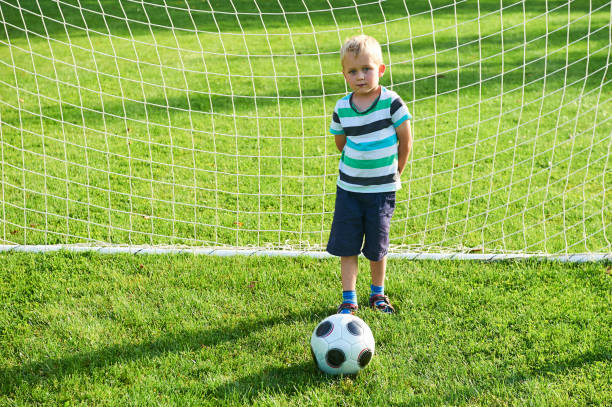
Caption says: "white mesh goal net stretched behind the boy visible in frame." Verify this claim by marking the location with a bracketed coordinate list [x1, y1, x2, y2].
[0, 0, 612, 255]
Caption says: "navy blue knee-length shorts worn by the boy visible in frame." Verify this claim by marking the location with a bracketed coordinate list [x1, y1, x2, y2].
[327, 187, 395, 261]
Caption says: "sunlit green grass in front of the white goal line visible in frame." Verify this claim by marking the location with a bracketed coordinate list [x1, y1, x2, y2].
[0, 252, 612, 406]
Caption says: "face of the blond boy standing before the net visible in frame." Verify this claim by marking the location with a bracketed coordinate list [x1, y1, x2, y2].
[342, 52, 385, 96]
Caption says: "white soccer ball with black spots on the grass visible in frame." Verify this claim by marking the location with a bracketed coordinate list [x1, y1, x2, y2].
[310, 314, 374, 375]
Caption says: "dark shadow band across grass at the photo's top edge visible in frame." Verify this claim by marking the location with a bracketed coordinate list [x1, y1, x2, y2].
[0, 0, 606, 38]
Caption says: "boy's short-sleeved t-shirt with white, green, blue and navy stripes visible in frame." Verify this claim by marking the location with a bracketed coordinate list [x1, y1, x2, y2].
[329, 86, 412, 192]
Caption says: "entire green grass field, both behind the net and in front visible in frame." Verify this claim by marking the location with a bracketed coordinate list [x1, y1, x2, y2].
[0, 0, 612, 406]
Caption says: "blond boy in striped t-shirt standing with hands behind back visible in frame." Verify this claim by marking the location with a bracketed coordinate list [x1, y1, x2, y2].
[327, 35, 412, 314]
